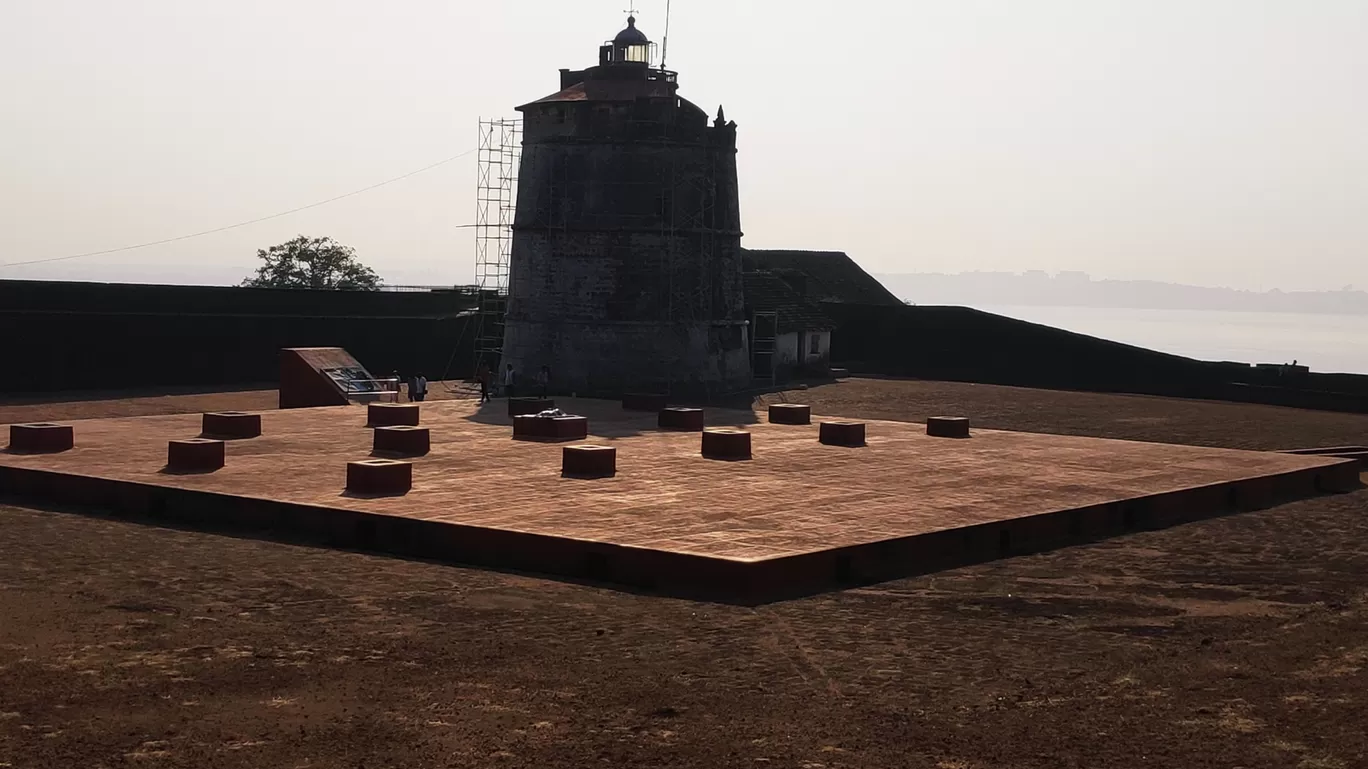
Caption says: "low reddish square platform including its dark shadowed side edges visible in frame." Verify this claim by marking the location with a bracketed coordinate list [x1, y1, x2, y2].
[0, 400, 1358, 601]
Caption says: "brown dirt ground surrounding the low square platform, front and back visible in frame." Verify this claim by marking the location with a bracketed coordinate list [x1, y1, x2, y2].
[0, 379, 1368, 769]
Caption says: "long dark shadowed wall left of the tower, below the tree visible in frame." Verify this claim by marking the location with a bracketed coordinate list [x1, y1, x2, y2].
[0, 281, 473, 394]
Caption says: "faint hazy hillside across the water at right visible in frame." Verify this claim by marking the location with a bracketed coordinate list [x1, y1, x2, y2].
[876, 271, 1368, 315]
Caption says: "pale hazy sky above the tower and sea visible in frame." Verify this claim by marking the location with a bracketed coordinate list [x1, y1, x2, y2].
[0, 0, 1368, 289]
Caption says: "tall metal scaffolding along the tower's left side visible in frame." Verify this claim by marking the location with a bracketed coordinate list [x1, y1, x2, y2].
[475, 118, 523, 371]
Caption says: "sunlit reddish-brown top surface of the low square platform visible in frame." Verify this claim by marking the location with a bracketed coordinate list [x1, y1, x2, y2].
[0, 400, 1338, 562]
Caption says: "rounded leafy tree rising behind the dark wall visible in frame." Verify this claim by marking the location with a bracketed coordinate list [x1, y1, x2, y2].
[242, 235, 380, 291]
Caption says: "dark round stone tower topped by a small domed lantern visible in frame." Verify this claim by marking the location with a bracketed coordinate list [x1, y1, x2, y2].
[503, 18, 751, 394]
